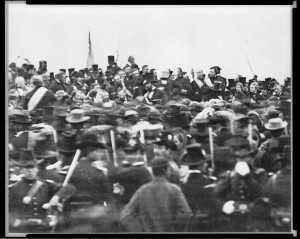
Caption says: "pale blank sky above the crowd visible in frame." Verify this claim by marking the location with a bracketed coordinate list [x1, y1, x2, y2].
[6, 2, 292, 82]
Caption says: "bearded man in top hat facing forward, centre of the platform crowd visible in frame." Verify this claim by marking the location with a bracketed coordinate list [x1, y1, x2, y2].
[144, 73, 168, 105]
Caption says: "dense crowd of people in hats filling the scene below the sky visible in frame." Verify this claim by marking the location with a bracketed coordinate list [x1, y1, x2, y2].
[7, 56, 292, 233]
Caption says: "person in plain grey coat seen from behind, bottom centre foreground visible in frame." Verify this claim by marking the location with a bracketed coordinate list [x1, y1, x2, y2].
[121, 158, 191, 232]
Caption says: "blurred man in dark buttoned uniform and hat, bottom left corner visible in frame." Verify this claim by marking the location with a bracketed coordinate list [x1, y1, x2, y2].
[8, 149, 76, 233]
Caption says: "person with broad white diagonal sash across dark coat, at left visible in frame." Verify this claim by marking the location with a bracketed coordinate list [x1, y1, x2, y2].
[22, 76, 57, 111]
